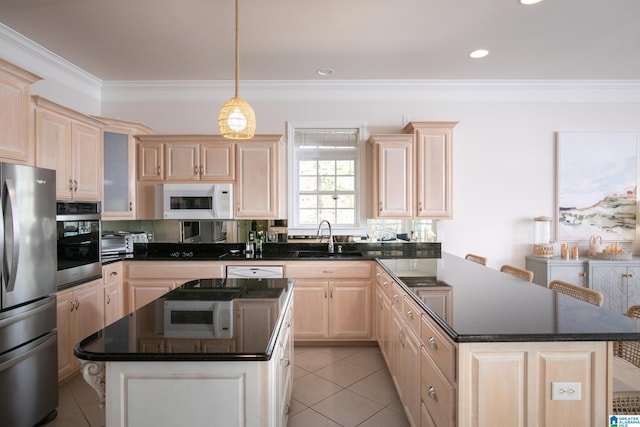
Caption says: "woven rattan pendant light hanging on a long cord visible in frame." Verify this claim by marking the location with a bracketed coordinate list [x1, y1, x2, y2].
[218, 0, 256, 139]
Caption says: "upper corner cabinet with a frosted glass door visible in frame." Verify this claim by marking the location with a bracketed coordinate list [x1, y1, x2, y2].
[96, 117, 152, 220]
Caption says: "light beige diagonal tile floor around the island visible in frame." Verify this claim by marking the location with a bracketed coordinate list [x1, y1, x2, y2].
[51, 347, 409, 427]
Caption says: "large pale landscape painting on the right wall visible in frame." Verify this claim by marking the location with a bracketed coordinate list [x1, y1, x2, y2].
[556, 132, 638, 242]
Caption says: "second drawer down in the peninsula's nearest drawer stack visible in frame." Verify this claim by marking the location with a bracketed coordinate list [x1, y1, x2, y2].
[420, 348, 456, 427]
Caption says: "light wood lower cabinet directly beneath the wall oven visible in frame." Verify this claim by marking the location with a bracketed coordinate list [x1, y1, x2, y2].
[56, 279, 104, 381]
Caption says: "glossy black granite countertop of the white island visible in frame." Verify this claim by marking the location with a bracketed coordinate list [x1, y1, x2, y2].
[74, 279, 293, 361]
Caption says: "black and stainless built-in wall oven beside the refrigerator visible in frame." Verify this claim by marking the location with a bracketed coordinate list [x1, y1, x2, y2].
[56, 202, 102, 289]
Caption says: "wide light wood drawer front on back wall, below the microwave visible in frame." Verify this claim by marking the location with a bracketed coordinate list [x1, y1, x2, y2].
[127, 261, 225, 280]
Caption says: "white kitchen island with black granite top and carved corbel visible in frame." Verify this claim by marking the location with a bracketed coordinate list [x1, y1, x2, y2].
[75, 279, 293, 426]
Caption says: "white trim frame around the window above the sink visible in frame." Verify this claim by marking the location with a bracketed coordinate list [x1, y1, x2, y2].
[287, 122, 369, 236]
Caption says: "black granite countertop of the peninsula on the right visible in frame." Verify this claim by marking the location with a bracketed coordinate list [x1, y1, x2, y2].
[387, 253, 640, 343]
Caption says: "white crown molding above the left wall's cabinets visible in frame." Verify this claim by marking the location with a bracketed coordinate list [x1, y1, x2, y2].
[0, 23, 102, 101]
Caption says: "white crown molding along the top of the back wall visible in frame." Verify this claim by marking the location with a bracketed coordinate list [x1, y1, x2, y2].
[103, 80, 640, 102]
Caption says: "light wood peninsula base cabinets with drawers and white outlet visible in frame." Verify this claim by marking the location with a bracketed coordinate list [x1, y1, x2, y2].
[375, 269, 612, 427]
